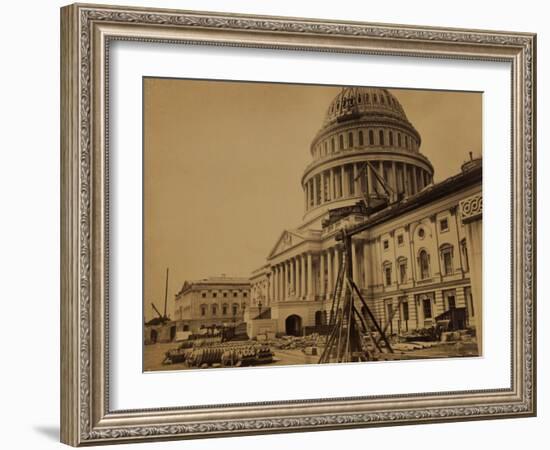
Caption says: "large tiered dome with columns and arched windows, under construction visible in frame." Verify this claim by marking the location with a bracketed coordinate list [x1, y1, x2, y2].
[302, 87, 433, 219]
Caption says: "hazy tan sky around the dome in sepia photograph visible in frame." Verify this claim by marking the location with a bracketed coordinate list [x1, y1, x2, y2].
[143, 78, 482, 319]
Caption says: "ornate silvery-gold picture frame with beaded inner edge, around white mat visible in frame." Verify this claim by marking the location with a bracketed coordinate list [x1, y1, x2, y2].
[61, 4, 536, 446]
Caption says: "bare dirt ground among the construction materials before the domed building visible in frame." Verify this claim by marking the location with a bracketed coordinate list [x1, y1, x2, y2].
[143, 341, 477, 372]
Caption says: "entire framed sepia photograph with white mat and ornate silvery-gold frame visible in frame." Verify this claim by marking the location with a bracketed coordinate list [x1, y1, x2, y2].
[61, 4, 536, 446]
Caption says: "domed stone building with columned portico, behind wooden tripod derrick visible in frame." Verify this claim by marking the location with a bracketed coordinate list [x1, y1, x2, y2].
[248, 87, 482, 348]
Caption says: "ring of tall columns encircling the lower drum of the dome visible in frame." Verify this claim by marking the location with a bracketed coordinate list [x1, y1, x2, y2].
[304, 161, 432, 211]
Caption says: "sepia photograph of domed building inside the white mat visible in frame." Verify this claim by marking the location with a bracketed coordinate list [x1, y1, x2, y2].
[142, 77, 483, 371]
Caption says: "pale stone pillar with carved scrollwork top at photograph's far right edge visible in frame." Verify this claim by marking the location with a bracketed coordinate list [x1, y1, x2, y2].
[459, 193, 483, 355]
